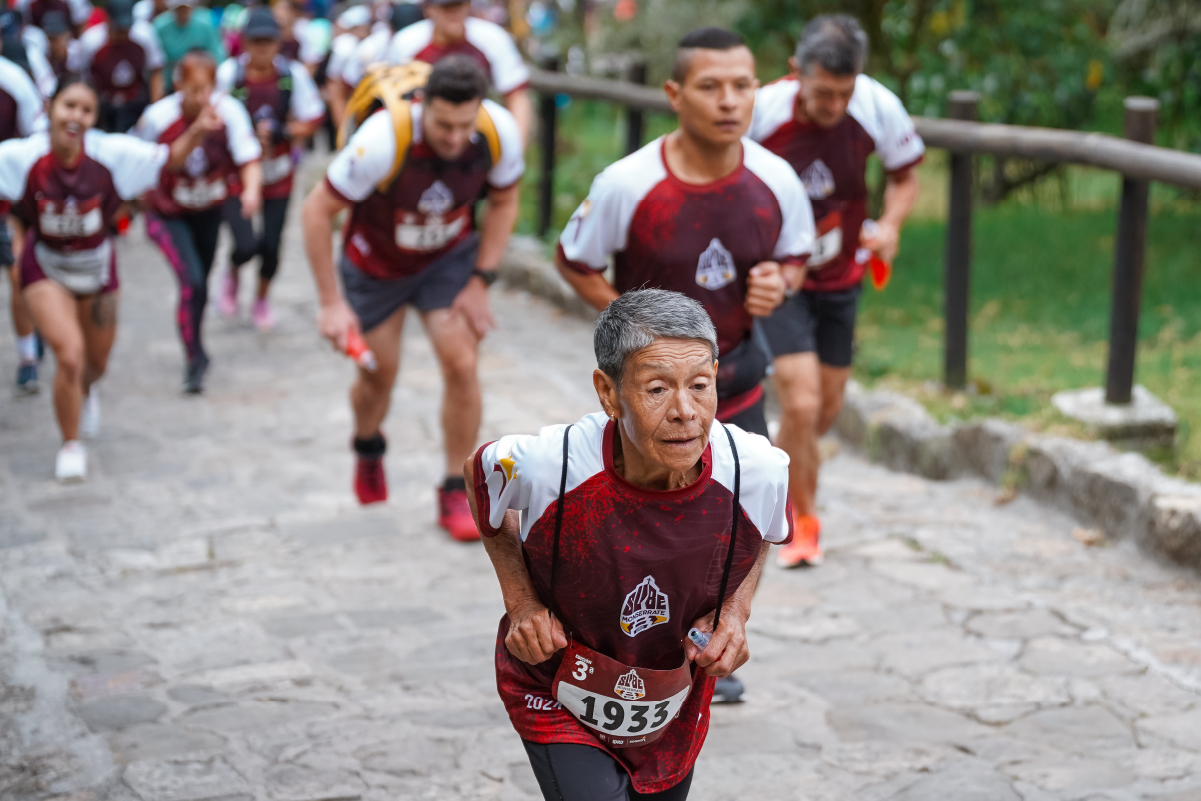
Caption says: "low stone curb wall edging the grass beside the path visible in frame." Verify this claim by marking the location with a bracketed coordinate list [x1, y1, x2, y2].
[501, 237, 1201, 568]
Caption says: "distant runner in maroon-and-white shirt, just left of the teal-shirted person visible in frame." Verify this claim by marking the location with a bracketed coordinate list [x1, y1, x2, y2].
[72, 0, 166, 132]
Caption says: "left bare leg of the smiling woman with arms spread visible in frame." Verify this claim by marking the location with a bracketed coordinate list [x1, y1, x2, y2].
[24, 280, 84, 442]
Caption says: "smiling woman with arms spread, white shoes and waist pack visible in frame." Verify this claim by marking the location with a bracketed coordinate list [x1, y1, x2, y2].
[0, 77, 212, 482]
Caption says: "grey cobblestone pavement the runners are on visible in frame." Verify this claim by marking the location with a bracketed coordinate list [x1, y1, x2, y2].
[0, 181, 1201, 801]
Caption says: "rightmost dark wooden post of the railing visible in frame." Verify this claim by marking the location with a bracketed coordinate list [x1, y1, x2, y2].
[1105, 97, 1159, 404]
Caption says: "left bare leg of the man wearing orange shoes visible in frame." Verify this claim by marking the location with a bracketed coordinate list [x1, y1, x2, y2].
[772, 353, 821, 515]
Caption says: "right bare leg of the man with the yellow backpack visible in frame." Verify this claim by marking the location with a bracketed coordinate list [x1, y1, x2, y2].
[422, 309, 483, 476]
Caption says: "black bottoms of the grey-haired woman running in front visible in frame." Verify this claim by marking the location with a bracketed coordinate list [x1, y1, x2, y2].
[521, 740, 692, 801]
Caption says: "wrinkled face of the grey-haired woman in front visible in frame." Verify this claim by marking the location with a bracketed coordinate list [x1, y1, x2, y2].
[607, 339, 717, 472]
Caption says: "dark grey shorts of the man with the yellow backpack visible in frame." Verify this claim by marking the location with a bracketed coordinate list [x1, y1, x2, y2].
[339, 233, 479, 331]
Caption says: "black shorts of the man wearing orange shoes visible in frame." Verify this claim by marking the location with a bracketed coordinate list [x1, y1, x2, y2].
[763, 285, 864, 367]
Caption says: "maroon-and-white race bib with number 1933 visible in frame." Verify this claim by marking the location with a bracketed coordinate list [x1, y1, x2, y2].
[551, 640, 692, 748]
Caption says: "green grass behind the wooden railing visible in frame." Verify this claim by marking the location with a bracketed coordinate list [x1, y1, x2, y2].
[519, 102, 1201, 478]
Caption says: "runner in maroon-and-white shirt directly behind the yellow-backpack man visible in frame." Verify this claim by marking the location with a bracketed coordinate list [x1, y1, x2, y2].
[346, 0, 533, 139]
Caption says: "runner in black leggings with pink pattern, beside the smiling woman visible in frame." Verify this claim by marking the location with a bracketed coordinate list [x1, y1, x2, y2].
[135, 50, 263, 394]
